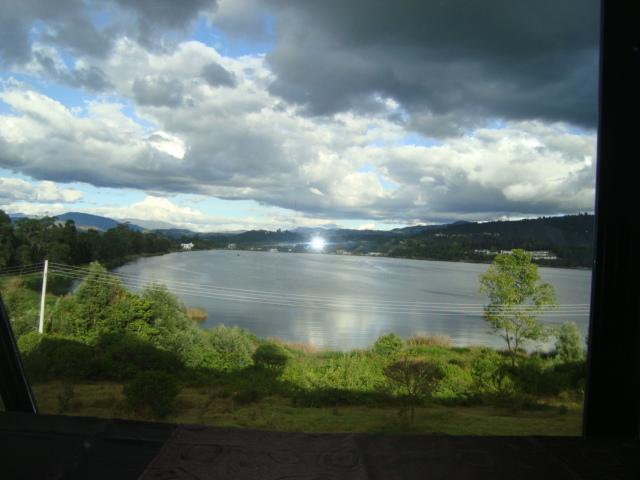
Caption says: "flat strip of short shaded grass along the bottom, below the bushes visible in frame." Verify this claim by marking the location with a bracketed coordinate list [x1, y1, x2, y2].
[33, 382, 582, 436]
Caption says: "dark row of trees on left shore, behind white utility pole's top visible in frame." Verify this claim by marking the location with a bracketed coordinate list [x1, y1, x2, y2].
[0, 210, 179, 268]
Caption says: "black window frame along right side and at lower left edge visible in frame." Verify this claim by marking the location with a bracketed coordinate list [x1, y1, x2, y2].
[0, 0, 640, 437]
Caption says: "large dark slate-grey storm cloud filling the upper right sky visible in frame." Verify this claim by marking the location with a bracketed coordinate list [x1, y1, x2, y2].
[268, 0, 598, 135]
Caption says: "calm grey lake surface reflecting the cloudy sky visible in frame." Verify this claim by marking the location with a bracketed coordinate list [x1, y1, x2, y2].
[115, 250, 591, 350]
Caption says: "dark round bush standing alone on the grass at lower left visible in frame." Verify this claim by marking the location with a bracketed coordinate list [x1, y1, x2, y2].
[122, 370, 180, 418]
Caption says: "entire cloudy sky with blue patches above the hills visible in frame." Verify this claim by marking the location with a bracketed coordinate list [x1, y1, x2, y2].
[0, 0, 599, 231]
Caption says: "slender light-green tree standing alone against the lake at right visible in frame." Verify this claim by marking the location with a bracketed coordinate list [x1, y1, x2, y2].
[480, 250, 556, 364]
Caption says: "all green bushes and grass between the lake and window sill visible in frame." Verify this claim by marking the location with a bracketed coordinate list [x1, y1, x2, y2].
[0, 264, 585, 435]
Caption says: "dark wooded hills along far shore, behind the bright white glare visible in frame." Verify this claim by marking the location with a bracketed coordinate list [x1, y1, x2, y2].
[166, 214, 595, 268]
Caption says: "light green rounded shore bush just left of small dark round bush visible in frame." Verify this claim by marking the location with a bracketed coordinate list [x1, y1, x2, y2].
[207, 325, 254, 372]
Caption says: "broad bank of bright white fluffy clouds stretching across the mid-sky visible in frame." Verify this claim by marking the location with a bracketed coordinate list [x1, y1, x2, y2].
[0, 34, 595, 226]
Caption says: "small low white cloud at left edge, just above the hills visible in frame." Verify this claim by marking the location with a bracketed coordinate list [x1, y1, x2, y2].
[0, 177, 82, 203]
